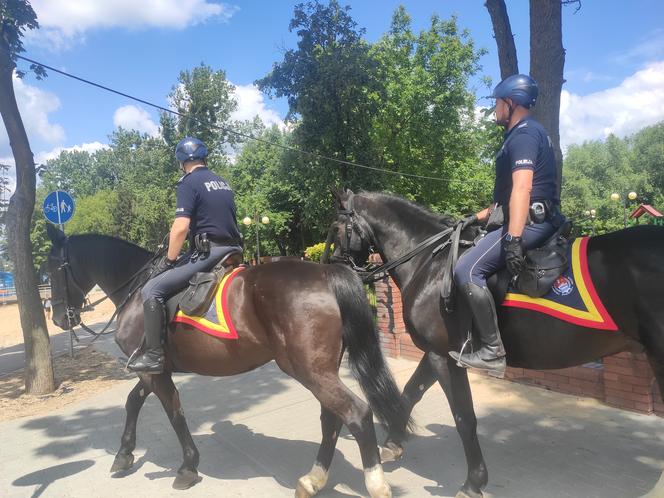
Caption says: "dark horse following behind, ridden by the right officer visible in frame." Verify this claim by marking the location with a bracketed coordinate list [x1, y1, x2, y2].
[334, 191, 664, 498]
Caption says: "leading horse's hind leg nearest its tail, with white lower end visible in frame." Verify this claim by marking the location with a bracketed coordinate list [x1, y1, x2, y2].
[296, 375, 392, 498]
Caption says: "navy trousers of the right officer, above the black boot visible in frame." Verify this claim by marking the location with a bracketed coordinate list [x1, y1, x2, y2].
[454, 221, 556, 287]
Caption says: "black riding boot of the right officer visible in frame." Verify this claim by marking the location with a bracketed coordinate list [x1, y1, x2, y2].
[450, 282, 506, 378]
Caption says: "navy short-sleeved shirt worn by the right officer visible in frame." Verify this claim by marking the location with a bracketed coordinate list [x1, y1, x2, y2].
[493, 117, 560, 206]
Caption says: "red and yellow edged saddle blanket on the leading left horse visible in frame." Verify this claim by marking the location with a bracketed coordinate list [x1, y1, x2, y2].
[173, 266, 245, 339]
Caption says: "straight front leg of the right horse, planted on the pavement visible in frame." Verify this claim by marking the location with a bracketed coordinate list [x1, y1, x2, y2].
[427, 352, 489, 498]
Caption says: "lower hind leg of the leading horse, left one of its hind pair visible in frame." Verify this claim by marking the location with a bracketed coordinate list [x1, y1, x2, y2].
[295, 404, 343, 498]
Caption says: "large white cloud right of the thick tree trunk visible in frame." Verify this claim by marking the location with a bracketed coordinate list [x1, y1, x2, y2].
[560, 61, 664, 150]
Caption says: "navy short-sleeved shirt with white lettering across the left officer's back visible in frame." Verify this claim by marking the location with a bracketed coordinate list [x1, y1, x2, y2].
[175, 166, 240, 244]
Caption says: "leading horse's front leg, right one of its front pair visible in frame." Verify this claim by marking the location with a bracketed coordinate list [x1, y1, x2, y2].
[146, 373, 200, 489]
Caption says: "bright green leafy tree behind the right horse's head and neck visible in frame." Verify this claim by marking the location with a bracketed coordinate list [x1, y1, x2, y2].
[371, 7, 497, 212]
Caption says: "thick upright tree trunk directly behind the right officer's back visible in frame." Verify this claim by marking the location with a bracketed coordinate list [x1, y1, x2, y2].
[530, 0, 565, 198]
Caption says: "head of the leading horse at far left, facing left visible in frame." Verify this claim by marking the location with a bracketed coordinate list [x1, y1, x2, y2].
[46, 223, 93, 330]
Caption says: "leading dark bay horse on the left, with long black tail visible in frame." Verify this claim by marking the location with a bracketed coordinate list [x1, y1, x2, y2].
[48, 225, 409, 498]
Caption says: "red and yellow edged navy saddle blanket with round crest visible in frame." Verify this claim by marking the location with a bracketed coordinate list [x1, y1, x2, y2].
[503, 237, 618, 330]
